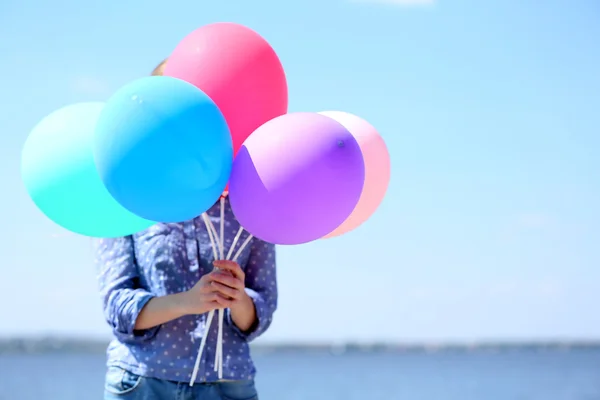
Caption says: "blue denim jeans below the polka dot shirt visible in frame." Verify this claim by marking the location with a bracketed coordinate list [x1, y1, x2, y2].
[104, 367, 258, 400]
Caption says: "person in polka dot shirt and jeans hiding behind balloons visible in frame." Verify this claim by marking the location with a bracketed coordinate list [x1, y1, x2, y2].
[96, 60, 277, 400]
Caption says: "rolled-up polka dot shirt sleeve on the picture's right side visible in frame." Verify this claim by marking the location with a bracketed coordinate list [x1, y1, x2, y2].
[225, 238, 277, 342]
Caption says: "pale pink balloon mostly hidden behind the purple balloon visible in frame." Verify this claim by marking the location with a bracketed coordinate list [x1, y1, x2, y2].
[319, 111, 391, 238]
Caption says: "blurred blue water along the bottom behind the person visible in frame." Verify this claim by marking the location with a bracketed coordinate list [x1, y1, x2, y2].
[0, 349, 600, 400]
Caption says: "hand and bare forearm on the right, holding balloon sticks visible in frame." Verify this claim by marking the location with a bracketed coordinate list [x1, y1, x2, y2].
[210, 260, 256, 331]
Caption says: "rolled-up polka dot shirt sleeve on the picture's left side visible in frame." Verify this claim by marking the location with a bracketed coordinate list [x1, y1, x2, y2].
[95, 236, 159, 344]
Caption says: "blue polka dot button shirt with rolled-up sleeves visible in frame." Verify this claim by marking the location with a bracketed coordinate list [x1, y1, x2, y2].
[95, 201, 277, 382]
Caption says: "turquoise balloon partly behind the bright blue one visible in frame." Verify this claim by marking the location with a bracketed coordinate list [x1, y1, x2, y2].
[21, 103, 154, 237]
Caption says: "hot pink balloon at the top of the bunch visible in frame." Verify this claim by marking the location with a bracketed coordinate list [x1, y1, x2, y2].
[164, 23, 288, 154]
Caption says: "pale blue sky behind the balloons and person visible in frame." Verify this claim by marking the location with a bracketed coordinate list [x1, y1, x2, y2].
[0, 0, 600, 342]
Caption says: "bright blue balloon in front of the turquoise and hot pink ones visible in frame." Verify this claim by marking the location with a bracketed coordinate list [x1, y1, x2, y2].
[94, 76, 233, 222]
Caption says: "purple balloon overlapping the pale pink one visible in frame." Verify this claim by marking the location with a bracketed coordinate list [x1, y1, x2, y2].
[229, 113, 365, 244]
